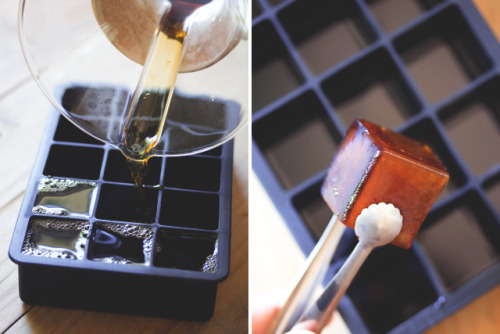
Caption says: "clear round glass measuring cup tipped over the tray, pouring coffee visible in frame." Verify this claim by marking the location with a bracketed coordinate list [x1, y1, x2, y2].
[19, 0, 248, 160]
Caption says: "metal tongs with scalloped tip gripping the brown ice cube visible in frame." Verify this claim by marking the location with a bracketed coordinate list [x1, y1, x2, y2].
[266, 203, 403, 334]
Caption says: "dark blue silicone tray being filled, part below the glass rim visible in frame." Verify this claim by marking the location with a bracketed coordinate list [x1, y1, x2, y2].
[9, 92, 233, 320]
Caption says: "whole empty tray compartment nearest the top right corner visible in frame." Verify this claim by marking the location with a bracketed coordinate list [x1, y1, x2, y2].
[394, 6, 492, 104]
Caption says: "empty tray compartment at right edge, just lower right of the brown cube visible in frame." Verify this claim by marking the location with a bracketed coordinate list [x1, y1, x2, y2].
[416, 192, 500, 291]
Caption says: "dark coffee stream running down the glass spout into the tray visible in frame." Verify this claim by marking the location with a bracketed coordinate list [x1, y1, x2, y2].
[119, 2, 204, 190]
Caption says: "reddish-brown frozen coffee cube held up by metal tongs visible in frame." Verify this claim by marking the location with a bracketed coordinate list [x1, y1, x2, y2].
[321, 119, 449, 248]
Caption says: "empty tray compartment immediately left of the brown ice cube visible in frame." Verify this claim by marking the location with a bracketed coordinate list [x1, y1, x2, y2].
[252, 91, 339, 189]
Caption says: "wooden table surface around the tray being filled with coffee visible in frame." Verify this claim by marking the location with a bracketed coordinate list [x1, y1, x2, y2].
[0, 0, 248, 334]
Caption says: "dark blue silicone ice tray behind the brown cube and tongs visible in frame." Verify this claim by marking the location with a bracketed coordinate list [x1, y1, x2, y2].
[252, 0, 500, 334]
